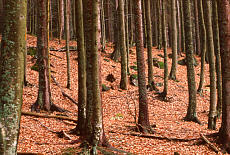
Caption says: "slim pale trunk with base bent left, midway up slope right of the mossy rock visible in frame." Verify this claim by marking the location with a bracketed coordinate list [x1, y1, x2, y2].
[169, 0, 177, 80]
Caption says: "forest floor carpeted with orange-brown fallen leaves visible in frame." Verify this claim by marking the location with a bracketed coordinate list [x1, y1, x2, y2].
[18, 35, 221, 154]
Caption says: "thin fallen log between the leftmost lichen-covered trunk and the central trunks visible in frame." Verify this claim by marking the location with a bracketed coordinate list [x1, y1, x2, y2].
[22, 111, 77, 123]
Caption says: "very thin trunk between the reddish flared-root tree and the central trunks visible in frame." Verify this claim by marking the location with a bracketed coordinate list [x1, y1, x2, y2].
[65, 0, 70, 89]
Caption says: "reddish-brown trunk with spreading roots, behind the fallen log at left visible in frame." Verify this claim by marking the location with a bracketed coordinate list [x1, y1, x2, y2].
[31, 0, 64, 112]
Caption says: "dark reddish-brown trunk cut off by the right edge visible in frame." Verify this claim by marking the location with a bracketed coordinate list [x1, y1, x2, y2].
[217, 0, 230, 153]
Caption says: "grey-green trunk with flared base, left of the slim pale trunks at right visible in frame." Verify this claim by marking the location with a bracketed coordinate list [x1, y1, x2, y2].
[183, 0, 200, 123]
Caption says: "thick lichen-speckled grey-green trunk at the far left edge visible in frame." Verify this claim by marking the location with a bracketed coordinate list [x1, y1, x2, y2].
[0, 0, 27, 155]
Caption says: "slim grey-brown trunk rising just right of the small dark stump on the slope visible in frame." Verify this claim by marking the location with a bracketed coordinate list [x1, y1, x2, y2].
[118, 0, 128, 90]
